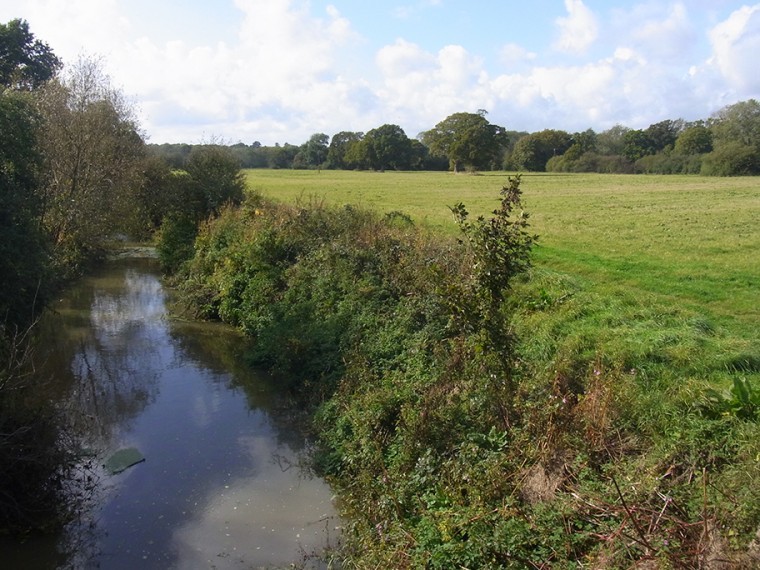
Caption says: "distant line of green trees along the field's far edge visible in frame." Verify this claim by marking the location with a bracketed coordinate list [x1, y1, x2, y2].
[148, 99, 760, 176]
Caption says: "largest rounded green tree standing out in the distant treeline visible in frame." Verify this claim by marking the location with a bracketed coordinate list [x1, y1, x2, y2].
[421, 111, 507, 172]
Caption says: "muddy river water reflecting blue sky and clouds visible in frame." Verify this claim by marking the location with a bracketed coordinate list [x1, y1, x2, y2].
[0, 255, 338, 569]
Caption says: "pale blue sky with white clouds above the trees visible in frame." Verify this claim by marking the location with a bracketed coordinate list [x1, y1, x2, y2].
[0, 0, 760, 145]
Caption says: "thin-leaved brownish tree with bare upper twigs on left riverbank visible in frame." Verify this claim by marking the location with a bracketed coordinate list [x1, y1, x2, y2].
[36, 58, 145, 272]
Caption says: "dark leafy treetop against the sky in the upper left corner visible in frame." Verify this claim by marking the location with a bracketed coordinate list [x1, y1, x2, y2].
[0, 19, 61, 91]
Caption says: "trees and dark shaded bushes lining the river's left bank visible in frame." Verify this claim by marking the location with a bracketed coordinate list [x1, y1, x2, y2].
[0, 19, 144, 533]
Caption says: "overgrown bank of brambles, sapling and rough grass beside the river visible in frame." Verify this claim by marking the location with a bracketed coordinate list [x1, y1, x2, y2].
[171, 181, 760, 568]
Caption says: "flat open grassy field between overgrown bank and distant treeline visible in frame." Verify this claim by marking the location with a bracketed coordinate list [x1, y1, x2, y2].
[246, 170, 760, 330]
